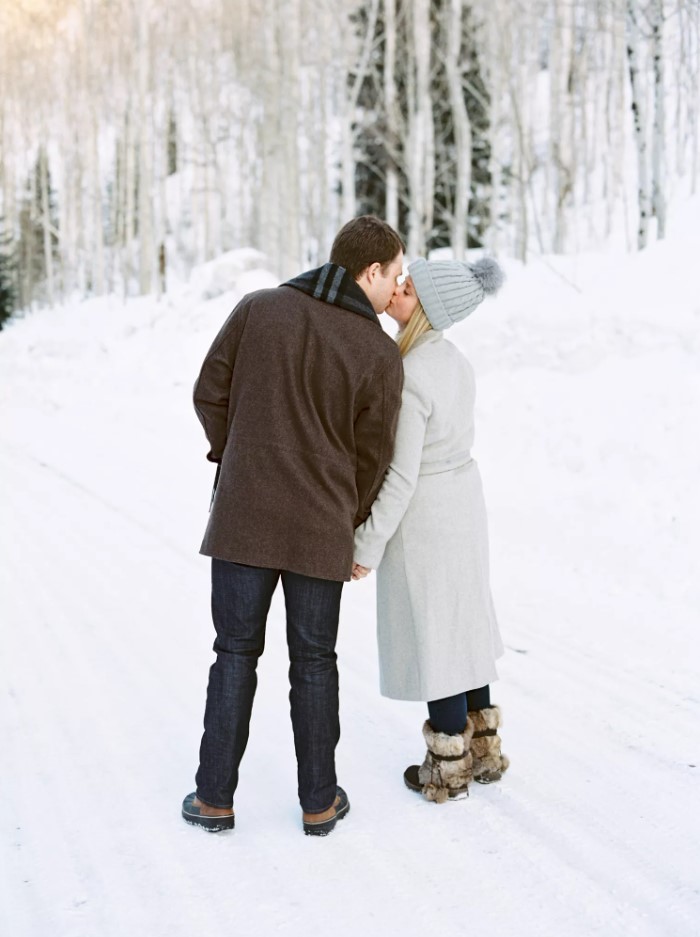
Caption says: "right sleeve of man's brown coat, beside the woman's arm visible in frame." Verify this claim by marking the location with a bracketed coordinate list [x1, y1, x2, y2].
[355, 349, 403, 527]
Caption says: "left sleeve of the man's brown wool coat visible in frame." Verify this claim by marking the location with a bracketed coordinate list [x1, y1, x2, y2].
[194, 297, 249, 462]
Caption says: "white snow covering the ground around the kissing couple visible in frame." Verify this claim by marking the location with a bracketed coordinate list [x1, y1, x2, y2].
[0, 214, 700, 937]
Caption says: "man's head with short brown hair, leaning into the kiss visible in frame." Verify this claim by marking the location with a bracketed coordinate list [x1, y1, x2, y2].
[330, 215, 405, 312]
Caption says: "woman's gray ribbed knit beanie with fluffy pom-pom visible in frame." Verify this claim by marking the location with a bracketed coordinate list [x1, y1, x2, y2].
[408, 257, 505, 330]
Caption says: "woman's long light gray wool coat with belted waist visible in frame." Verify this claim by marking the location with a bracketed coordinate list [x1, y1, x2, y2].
[355, 331, 503, 701]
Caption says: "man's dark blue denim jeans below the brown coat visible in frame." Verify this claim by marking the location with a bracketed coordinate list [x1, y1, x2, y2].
[197, 559, 343, 813]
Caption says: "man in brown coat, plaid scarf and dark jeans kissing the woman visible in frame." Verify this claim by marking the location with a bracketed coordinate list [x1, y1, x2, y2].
[182, 215, 404, 835]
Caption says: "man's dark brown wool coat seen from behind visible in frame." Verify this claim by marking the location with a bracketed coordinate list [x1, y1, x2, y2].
[194, 286, 403, 580]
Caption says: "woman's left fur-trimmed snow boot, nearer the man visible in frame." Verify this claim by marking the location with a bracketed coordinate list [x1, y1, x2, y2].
[403, 718, 474, 804]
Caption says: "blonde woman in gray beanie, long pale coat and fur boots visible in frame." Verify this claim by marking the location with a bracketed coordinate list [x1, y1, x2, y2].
[353, 259, 508, 803]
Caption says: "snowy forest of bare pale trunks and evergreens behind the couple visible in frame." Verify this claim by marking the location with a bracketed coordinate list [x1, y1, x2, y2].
[0, 0, 700, 314]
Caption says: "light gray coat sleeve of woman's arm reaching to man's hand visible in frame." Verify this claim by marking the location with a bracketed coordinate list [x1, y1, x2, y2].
[354, 373, 431, 569]
